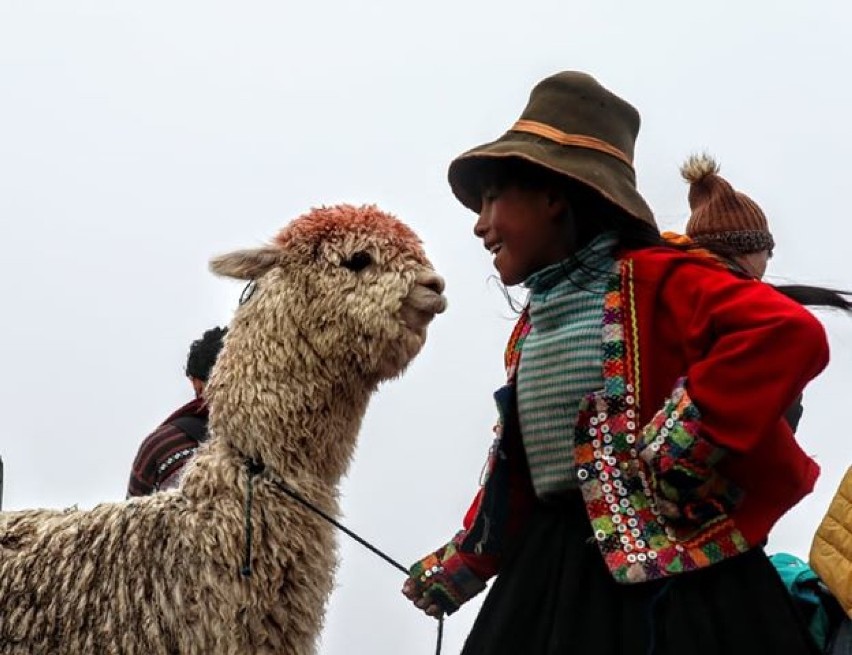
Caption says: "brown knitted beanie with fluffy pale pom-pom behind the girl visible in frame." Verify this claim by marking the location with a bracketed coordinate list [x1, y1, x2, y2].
[680, 155, 775, 255]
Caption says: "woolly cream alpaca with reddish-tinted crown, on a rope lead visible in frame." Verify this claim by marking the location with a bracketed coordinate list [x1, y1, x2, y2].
[0, 205, 446, 655]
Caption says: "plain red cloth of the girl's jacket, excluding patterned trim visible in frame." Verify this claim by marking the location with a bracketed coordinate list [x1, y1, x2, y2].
[629, 249, 828, 545]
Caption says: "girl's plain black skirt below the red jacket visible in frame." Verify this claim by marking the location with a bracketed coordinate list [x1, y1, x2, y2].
[462, 492, 818, 655]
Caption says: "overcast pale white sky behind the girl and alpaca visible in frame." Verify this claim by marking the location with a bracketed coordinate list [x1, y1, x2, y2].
[0, 0, 852, 655]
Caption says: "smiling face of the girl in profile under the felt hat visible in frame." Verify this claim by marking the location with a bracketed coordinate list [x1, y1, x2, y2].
[473, 185, 573, 286]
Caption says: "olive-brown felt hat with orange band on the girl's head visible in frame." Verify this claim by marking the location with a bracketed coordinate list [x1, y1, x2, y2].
[449, 71, 656, 227]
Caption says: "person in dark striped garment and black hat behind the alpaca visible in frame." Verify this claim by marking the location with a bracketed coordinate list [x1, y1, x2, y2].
[127, 327, 228, 498]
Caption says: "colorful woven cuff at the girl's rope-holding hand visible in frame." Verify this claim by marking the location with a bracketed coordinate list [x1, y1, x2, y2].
[409, 532, 485, 615]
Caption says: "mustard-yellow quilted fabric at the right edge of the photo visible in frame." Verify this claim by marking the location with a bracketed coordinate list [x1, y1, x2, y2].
[810, 467, 852, 617]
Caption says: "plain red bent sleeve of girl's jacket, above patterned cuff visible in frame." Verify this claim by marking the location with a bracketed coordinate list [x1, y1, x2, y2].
[661, 265, 828, 453]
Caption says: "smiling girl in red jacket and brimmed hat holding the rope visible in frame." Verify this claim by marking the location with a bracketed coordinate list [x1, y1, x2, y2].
[403, 72, 828, 655]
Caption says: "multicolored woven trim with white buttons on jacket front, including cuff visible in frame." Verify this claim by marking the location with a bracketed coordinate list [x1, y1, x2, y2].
[575, 262, 748, 583]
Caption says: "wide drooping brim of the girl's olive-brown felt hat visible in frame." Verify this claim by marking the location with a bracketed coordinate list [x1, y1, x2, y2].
[448, 132, 657, 227]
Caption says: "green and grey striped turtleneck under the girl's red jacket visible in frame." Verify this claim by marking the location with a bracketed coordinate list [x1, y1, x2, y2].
[517, 233, 616, 497]
